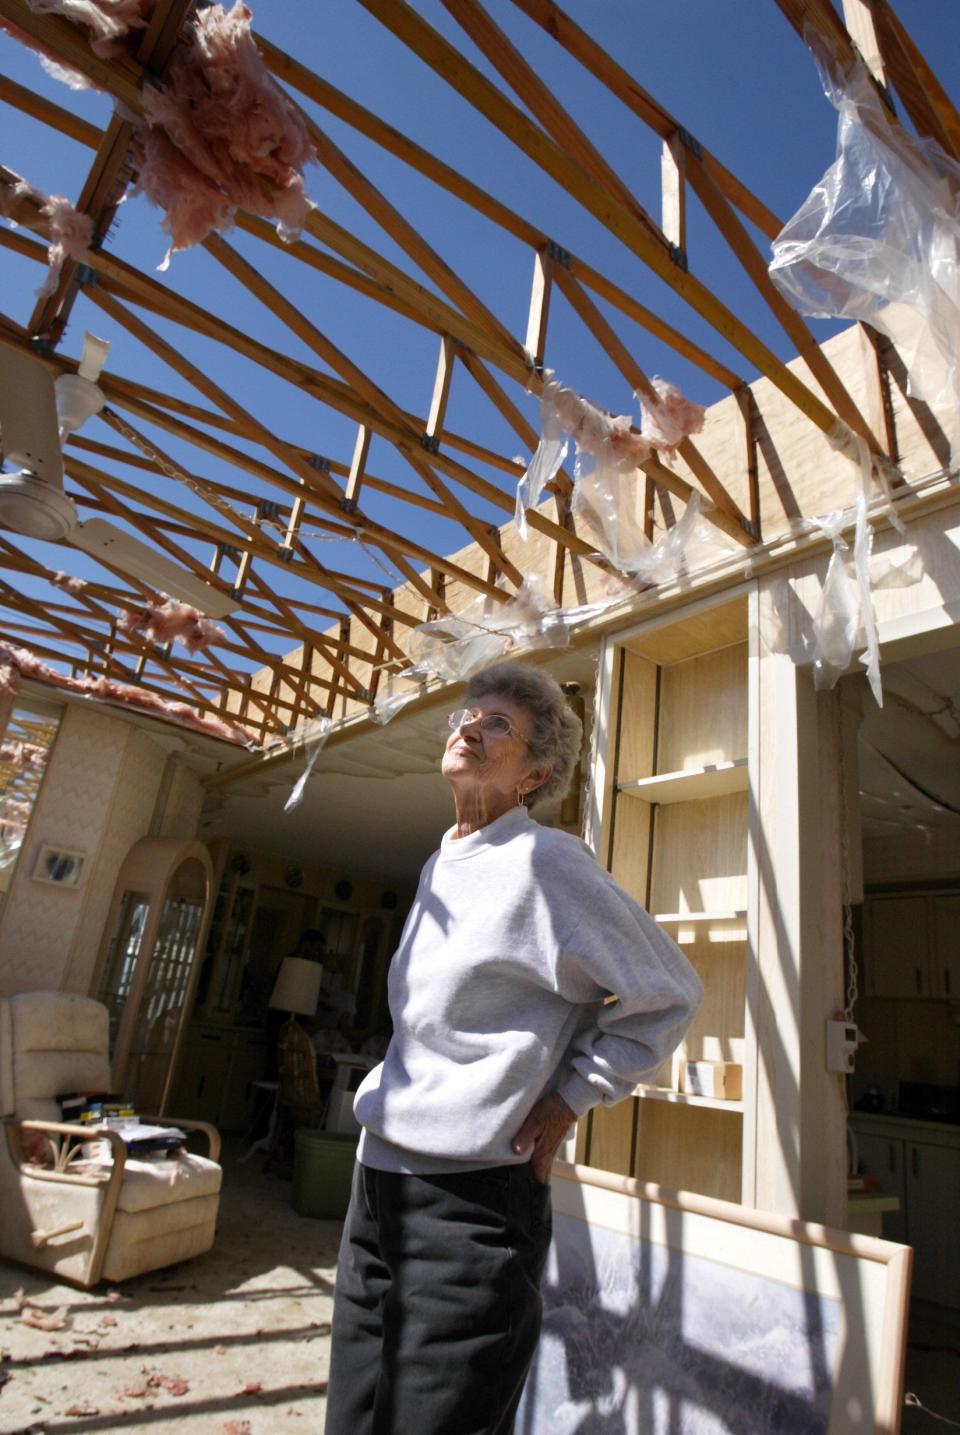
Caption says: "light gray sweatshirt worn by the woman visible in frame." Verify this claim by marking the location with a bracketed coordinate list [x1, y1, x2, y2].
[353, 808, 703, 1174]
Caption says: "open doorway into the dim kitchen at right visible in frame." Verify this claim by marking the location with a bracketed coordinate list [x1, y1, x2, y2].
[842, 649, 960, 1335]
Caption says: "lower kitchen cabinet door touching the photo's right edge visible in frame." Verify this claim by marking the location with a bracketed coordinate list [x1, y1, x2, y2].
[905, 1141, 960, 1309]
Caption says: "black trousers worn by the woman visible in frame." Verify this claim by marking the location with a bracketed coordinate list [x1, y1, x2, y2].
[324, 1164, 551, 1435]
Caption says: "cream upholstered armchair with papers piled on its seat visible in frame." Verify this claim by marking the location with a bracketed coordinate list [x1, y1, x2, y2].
[0, 992, 221, 1286]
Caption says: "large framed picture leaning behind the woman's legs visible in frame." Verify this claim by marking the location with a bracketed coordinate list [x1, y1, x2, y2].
[515, 1162, 913, 1435]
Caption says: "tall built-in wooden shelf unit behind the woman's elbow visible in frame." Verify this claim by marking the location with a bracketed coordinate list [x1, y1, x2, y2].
[577, 600, 748, 1201]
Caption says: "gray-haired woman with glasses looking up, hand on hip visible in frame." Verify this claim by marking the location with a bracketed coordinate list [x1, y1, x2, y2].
[326, 663, 700, 1435]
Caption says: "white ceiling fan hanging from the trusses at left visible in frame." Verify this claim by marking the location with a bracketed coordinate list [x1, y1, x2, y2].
[0, 334, 237, 618]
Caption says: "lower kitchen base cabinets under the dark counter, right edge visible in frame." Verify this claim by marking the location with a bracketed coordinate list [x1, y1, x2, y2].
[851, 1115, 960, 1309]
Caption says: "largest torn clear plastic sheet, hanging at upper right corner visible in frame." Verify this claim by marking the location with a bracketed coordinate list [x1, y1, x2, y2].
[769, 34, 960, 419]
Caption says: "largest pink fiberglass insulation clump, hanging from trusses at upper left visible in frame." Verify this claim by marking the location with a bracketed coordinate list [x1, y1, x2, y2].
[138, 0, 313, 258]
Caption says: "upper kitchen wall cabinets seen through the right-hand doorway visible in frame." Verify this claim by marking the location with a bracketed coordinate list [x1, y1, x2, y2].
[864, 891, 960, 1000]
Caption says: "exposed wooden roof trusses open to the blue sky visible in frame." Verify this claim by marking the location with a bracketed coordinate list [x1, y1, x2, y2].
[0, 0, 960, 742]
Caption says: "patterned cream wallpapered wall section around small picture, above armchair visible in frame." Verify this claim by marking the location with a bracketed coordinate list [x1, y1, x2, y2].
[0, 703, 166, 996]
